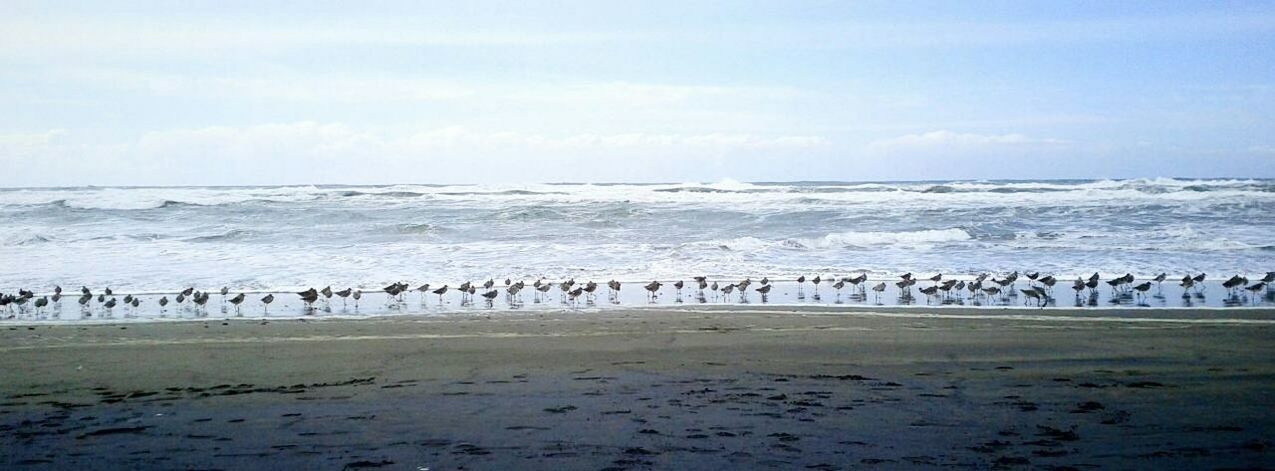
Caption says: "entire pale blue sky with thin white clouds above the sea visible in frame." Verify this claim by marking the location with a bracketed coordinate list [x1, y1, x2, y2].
[0, 0, 1275, 186]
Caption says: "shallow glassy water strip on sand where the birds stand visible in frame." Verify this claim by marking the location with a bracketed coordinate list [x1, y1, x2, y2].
[0, 280, 1275, 323]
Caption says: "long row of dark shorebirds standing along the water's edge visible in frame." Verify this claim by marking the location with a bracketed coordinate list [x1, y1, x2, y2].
[0, 272, 1275, 314]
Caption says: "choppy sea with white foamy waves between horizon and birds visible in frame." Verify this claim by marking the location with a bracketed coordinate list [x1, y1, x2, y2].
[0, 179, 1275, 292]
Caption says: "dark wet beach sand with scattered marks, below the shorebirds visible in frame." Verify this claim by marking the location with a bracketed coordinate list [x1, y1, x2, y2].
[0, 306, 1275, 470]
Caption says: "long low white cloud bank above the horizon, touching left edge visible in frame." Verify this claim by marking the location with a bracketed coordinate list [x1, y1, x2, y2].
[0, 121, 826, 186]
